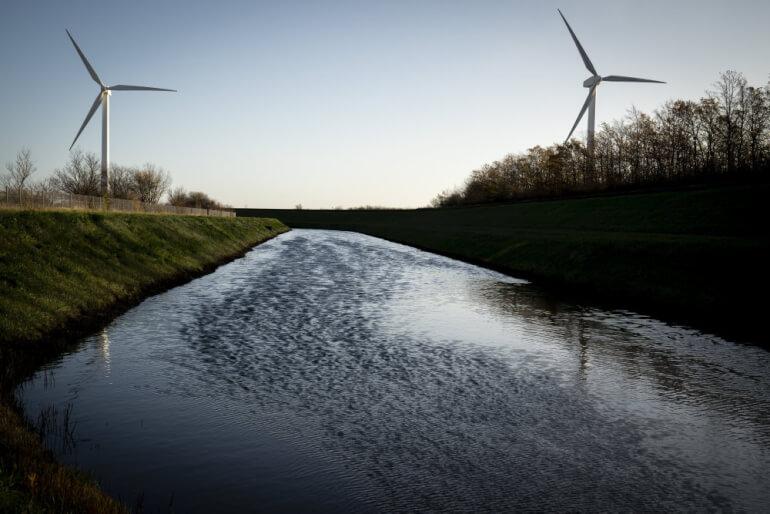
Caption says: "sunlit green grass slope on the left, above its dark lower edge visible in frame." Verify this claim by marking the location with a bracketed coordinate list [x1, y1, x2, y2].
[0, 211, 285, 345]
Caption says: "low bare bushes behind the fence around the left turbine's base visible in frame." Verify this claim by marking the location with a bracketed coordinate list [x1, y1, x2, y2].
[0, 148, 229, 209]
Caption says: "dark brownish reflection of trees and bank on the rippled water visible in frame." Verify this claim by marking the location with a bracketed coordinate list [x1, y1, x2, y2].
[468, 276, 770, 420]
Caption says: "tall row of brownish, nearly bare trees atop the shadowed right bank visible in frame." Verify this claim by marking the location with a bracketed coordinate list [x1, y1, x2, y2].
[432, 71, 770, 207]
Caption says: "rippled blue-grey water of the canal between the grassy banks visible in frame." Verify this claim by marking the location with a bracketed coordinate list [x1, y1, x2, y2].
[19, 230, 770, 512]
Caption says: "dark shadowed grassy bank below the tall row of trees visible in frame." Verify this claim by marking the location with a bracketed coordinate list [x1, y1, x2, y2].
[236, 184, 770, 345]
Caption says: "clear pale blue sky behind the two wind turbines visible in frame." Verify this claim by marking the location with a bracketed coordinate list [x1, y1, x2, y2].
[0, 0, 770, 208]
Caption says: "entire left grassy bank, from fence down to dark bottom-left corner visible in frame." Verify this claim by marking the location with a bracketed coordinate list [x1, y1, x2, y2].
[0, 211, 288, 512]
